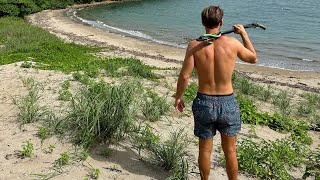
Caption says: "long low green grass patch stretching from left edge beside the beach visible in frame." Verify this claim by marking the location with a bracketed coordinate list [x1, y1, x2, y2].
[0, 17, 159, 79]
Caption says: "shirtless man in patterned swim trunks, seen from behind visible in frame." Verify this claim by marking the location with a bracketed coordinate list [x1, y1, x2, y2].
[175, 6, 257, 180]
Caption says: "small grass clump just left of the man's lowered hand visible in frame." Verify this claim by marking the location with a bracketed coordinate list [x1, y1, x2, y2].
[141, 91, 170, 122]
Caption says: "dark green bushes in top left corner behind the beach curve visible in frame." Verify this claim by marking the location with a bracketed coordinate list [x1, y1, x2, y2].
[0, 0, 103, 17]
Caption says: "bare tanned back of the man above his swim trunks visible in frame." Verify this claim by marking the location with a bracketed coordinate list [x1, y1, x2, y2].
[188, 27, 255, 95]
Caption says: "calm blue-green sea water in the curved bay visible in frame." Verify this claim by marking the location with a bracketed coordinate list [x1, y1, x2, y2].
[71, 0, 320, 71]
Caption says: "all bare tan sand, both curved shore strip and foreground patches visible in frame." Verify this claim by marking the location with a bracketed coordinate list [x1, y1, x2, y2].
[0, 2, 320, 180]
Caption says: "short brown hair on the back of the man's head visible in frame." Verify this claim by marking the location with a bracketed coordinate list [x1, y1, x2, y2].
[201, 6, 223, 29]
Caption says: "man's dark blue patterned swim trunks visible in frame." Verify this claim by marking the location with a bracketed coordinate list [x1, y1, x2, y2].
[192, 92, 241, 140]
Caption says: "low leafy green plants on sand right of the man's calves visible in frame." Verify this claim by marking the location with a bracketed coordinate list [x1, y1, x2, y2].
[237, 140, 307, 180]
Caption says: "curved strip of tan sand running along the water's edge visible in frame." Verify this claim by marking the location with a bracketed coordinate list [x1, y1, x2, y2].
[27, 1, 320, 92]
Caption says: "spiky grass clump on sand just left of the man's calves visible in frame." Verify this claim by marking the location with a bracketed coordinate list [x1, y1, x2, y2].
[151, 129, 188, 170]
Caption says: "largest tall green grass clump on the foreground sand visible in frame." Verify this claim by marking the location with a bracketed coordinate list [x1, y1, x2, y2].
[59, 81, 141, 147]
